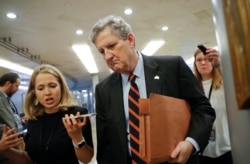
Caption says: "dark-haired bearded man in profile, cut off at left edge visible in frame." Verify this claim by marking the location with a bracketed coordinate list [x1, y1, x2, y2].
[0, 72, 22, 163]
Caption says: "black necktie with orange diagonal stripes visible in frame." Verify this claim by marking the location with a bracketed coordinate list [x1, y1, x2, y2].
[128, 74, 145, 164]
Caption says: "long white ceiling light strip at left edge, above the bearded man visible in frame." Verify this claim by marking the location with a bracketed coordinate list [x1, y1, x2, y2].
[0, 59, 33, 75]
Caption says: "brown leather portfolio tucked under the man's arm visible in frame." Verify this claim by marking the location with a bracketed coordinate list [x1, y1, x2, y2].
[139, 93, 191, 164]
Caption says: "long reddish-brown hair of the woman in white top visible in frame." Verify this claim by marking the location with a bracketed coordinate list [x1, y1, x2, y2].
[193, 49, 223, 89]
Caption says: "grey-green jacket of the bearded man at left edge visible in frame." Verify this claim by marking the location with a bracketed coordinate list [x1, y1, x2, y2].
[0, 91, 17, 163]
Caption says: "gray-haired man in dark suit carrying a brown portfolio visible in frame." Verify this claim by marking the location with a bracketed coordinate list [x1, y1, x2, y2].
[90, 15, 215, 164]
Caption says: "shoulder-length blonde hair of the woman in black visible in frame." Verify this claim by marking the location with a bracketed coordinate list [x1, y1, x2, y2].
[24, 64, 77, 119]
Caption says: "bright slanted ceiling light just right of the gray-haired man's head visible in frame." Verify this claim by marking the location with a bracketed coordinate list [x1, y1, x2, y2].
[142, 40, 165, 56]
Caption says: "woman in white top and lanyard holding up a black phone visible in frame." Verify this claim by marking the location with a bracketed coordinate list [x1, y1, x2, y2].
[194, 48, 233, 164]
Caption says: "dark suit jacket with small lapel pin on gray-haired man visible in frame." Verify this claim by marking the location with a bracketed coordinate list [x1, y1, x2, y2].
[95, 55, 215, 164]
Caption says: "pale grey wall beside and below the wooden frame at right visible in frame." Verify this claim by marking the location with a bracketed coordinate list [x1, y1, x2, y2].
[211, 0, 250, 164]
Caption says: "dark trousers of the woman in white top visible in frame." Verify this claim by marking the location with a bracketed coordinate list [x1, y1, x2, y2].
[200, 151, 233, 164]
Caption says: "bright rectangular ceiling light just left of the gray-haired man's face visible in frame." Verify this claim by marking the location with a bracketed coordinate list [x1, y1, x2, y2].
[72, 44, 98, 74]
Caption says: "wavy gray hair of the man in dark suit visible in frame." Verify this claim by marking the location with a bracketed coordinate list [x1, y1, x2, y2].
[89, 15, 132, 44]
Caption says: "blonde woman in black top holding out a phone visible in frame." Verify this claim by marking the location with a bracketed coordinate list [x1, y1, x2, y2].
[1, 64, 93, 164]
